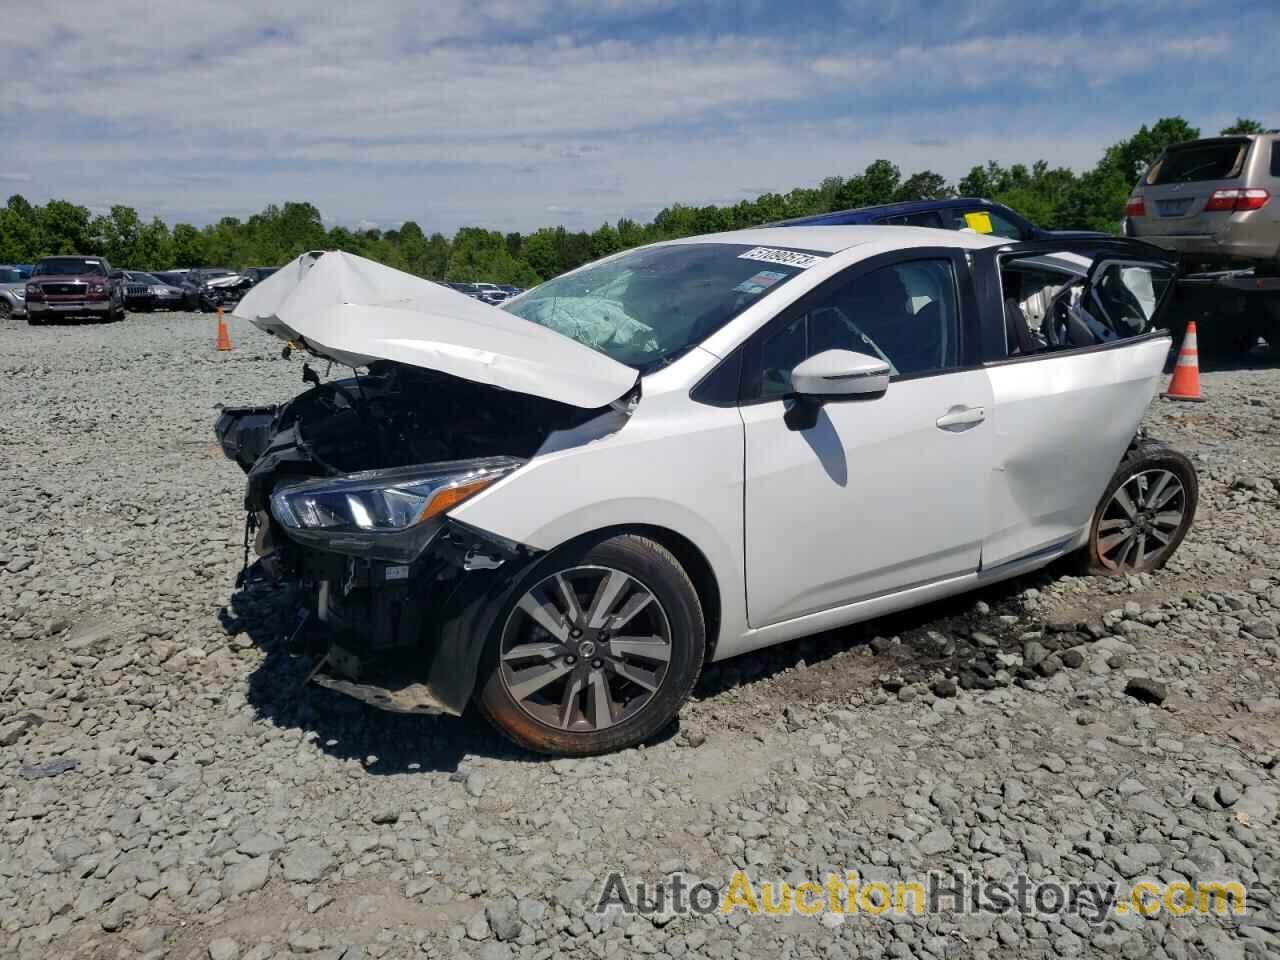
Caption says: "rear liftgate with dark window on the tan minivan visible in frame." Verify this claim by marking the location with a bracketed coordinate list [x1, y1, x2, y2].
[1135, 137, 1253, 244]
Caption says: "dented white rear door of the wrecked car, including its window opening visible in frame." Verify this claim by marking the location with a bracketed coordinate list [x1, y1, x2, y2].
[974, 241, 1175, 571]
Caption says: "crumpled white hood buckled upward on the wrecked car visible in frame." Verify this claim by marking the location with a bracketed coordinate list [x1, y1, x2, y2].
[233, 251, 639, 410]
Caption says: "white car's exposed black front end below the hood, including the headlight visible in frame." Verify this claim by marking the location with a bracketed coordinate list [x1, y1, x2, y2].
[216, 361, 626, 713]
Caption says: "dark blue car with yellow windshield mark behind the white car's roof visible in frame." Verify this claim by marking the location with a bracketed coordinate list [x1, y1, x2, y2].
[772, 197, 1103, 241]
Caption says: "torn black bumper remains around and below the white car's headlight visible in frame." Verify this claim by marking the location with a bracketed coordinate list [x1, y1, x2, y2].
[216, 407, 539, 716]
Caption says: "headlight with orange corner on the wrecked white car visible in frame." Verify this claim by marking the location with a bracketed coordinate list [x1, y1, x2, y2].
[271, 457, 525, 563]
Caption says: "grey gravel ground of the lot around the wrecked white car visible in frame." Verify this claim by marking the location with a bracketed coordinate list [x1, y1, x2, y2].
[0, 315, 1280, 960]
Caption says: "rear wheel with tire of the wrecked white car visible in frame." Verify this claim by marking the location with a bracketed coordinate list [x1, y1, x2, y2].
[1084, 440, 1199, 576]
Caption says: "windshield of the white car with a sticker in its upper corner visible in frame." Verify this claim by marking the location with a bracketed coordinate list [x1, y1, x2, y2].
[502, 243, 808, 371]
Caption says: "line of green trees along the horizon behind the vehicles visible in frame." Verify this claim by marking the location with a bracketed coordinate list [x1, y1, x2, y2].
[0, 116, 1265, 287]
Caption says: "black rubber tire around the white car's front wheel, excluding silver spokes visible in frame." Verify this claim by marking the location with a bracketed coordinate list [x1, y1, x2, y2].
[474, 534, 707, 756]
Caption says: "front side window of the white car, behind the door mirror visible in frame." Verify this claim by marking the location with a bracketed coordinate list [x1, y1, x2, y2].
[742, 260, 960, 401]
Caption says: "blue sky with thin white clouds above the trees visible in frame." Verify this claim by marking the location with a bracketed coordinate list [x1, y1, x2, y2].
[0, 0, 1280, 233]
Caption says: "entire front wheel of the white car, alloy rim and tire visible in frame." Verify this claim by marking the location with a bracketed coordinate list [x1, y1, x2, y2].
[476, 535, 705, 755]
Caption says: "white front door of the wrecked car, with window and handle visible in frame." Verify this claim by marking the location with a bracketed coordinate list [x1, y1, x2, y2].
[741, 248, 991, 627]
